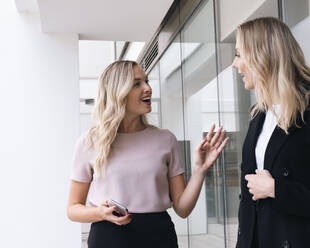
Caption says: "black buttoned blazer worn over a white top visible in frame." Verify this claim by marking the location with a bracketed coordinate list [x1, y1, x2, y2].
[236, 107, 310, 248]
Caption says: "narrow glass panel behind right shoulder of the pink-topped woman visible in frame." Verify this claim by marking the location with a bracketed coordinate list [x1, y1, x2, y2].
[159, 33, 188, 248]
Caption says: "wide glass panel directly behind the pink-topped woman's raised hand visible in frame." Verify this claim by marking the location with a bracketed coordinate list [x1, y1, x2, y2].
[181, 1, 225, 248]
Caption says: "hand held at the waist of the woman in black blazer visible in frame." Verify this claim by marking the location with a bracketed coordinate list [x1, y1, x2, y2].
[245, 170, 275, 201]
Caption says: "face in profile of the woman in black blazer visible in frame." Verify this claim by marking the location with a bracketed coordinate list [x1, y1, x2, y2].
[232, 35, 254, 90]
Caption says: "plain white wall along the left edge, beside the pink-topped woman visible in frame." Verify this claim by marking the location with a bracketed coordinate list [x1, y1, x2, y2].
[0, 1, 81, 248]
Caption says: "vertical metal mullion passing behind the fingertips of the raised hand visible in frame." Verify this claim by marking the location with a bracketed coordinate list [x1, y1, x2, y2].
[213, 0, 228, 247]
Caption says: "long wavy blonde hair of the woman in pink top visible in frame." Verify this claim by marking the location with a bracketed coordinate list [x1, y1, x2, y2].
[88, 60, 149, 177]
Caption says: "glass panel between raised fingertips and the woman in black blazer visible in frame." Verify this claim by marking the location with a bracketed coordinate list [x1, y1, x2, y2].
[218, 43, 255, 248]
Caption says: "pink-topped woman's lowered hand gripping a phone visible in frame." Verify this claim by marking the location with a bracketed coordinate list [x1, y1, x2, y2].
[98, 201, 132, 226]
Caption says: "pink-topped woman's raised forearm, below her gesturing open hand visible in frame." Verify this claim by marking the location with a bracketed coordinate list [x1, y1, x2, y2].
[174, 168, 205, 218]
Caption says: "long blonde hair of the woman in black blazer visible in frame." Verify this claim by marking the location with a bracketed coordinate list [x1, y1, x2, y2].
[237, 17, 310, 134]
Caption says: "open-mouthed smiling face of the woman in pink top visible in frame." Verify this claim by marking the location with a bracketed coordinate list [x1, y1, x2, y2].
[126, 65, 152, 116]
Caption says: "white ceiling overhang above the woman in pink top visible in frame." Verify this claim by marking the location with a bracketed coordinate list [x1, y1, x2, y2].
[32, 0, 173, 41]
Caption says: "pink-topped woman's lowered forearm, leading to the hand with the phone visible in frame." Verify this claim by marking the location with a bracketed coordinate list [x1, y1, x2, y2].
[67, 204, 103, 223]
